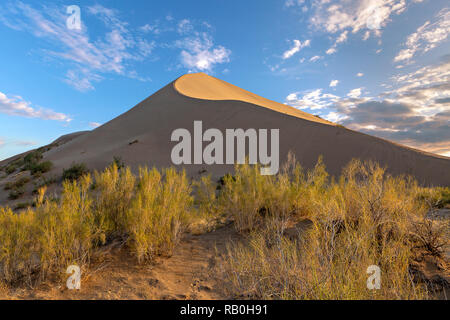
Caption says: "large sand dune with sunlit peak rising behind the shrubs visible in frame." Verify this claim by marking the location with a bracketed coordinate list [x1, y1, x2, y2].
[3, 73, 450, 190]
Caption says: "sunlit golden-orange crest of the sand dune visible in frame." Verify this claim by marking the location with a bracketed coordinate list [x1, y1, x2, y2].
[174, 72, 336, 126]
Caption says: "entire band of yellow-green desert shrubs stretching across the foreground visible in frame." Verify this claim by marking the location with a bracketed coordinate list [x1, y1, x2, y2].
[0, 157, 448, 299]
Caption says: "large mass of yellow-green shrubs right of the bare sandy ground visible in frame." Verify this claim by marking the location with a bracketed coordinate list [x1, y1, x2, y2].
[222, 160, 436, 299]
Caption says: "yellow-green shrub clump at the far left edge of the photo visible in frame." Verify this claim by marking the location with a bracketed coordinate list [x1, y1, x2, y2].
[0, 175, 95, 283]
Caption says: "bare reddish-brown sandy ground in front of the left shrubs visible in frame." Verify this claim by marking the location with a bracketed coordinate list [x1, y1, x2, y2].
[0, 226, 239, 299]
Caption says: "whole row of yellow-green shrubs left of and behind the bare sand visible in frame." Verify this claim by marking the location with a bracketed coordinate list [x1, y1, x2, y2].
[0, 163, 193, 284]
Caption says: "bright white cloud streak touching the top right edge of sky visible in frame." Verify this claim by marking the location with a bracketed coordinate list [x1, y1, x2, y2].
[394, 8, 450, 62]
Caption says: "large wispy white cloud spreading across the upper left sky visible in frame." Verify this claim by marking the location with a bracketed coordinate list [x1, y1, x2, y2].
[0, 2, 154, 91]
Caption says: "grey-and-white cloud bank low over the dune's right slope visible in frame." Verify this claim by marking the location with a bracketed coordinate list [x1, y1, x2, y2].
[286, 55, 450, 155]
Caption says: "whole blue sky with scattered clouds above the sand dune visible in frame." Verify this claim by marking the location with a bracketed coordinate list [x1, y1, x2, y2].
[0, 0, 450, 159]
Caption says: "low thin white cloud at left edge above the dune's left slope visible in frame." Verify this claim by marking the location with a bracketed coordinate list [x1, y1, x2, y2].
[0, 92, 72, 122]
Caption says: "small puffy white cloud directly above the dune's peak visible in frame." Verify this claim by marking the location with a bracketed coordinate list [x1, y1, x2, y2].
[176, 32, 231, 71]
